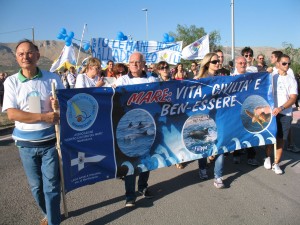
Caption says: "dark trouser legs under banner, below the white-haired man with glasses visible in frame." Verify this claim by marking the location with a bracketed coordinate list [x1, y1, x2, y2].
[125, 171, 150, 200]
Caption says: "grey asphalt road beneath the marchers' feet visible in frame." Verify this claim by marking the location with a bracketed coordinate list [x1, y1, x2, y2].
[0, 132, 300, 225]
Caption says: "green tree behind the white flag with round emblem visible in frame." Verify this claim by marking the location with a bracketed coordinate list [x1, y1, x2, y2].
[169, 24, 221, 66]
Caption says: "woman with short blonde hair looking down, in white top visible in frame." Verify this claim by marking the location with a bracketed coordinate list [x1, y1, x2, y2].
[75, 57, 105, 88]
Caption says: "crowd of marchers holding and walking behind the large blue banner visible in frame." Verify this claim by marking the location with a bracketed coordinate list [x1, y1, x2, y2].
[0, 40, 298, 224]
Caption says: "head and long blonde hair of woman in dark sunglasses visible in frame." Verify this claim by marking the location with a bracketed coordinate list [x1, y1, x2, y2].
[194, 53, 220, 80]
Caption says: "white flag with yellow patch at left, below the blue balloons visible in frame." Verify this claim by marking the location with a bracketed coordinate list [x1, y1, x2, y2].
[50, 45, 76, 72]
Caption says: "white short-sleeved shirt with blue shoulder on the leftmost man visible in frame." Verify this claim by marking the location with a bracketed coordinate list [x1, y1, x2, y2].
[2, 70, 65, 139]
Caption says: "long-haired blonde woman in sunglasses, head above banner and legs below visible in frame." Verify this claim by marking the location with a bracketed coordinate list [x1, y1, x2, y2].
[195, 53, 224, 188]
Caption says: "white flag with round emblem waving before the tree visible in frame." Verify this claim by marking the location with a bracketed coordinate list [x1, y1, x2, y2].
[181, 34, 209, 60]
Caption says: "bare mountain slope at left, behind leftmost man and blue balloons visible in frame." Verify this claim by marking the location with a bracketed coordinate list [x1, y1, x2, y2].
[0, 40, 90, 74]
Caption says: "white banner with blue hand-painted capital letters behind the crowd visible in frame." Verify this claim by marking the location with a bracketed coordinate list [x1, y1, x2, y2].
[91, 38, 182, 65]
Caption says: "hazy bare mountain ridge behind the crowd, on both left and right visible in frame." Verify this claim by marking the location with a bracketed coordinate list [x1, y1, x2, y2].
[0, 40, 277, 74]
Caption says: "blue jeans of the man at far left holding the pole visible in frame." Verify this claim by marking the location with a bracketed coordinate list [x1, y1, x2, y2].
[19, 146, 60, 225]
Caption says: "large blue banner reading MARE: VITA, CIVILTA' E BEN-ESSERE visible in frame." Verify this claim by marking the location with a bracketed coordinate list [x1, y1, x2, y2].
[58, 73, 276, 191]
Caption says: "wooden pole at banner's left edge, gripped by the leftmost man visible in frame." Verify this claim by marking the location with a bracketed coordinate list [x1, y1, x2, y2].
[51, 82, 68, 218]
